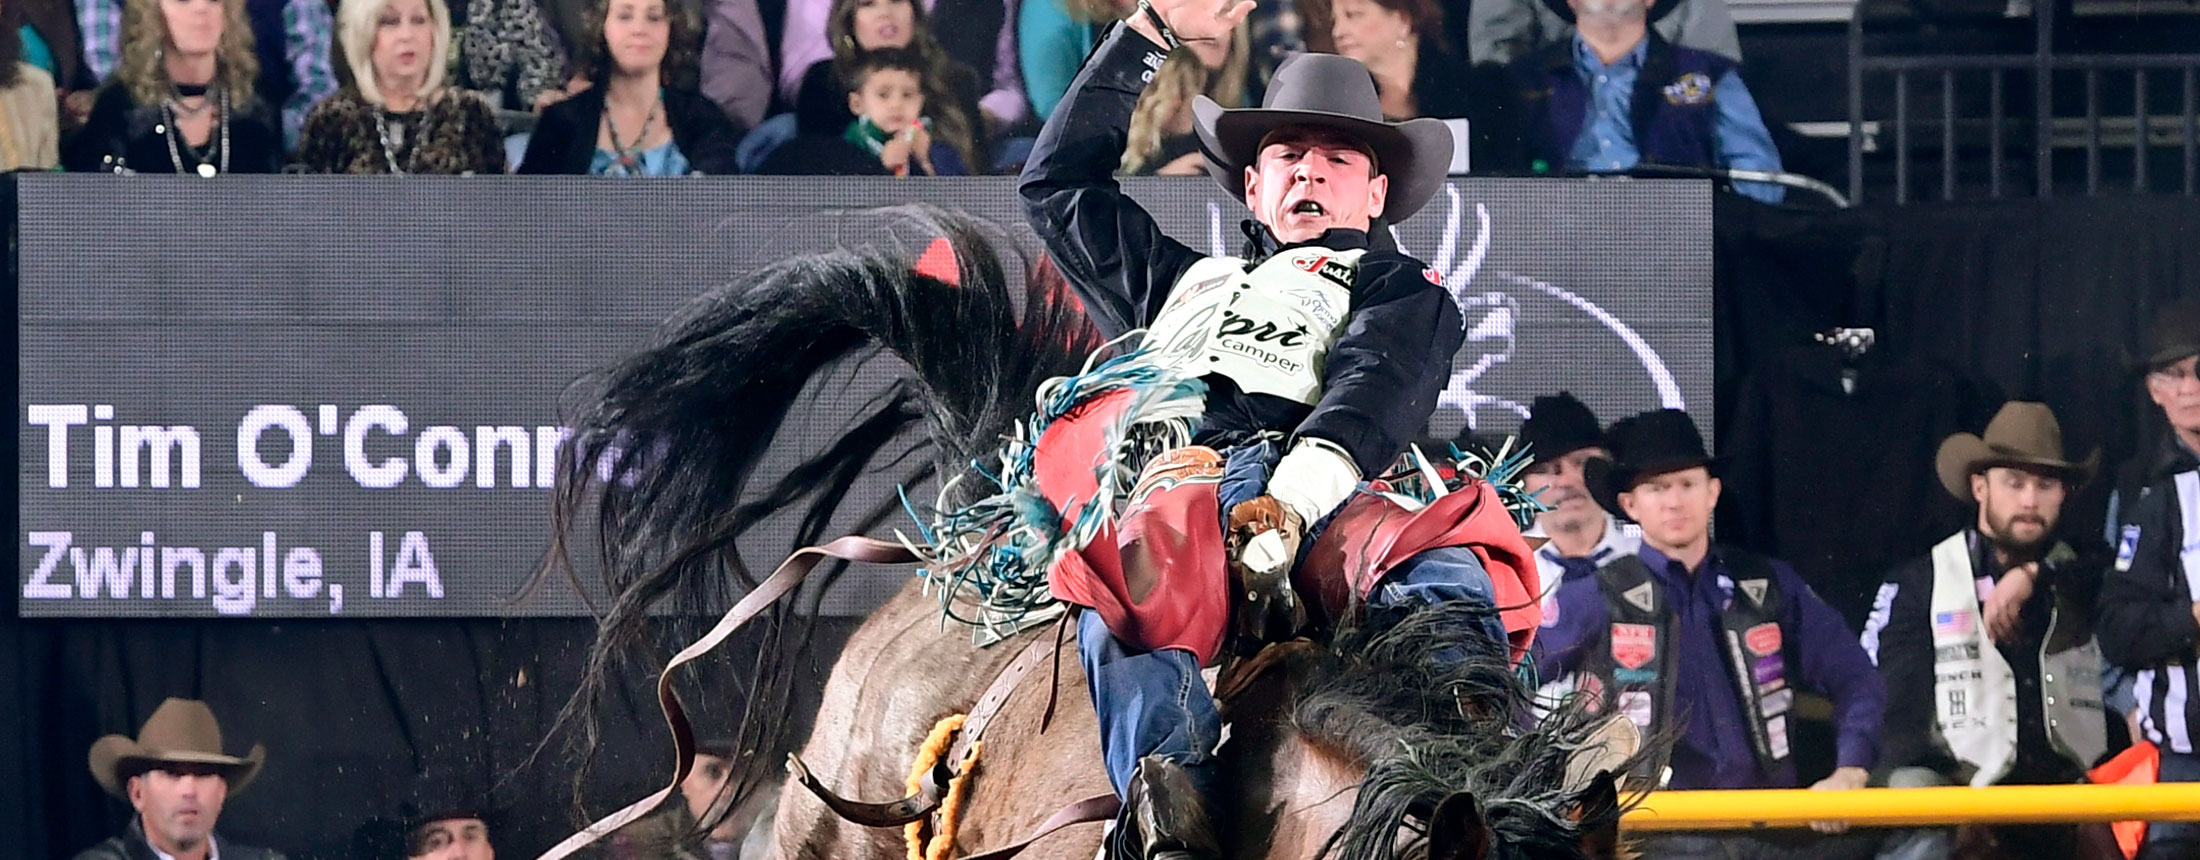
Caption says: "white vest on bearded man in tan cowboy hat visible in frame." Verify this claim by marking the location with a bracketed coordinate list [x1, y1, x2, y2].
[1932, 532, 2108, 787]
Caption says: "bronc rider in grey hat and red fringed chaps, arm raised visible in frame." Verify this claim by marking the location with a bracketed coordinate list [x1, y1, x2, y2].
[1003, 0, 1538, 860]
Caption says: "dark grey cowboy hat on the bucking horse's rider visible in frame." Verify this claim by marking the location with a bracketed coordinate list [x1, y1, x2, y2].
[1192, 53, 1452, 224]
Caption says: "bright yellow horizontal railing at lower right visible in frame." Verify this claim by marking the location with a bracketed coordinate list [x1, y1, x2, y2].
[1621, 783, 2200, 831]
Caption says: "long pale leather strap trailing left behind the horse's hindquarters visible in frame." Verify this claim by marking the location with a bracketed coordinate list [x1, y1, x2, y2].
[537, 537, 920, 860]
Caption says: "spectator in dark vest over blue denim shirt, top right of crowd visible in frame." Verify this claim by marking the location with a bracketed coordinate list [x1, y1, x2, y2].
[1511, 0, 1784, 202]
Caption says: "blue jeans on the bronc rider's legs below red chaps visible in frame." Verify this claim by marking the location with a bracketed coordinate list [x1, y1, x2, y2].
[1078, 548, 1505, 796]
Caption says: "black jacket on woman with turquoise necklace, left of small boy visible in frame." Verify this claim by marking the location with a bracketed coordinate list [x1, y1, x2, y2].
[519, 84, 741, 176]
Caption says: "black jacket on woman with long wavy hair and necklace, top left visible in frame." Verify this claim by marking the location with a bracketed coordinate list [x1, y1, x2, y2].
[62, 84, 282, 174]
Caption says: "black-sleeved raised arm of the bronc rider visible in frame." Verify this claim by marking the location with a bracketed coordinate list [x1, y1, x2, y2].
[1021, 24, 1199, 337]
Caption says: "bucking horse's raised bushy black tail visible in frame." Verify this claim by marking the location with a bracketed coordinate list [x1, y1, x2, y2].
[539, 207, 1098, 827]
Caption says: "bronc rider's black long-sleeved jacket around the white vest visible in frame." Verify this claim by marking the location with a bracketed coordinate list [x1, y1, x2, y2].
[1021, 24, 1465, 475]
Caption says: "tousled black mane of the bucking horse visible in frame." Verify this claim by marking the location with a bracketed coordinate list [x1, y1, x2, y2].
[1294, 603, 1654, 860]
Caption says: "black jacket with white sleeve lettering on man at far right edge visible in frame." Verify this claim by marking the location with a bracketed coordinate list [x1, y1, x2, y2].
[2099, 470, 2200, 752]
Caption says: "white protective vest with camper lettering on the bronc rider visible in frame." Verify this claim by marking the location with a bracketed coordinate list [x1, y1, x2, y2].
[1144, 246, 1366, 407]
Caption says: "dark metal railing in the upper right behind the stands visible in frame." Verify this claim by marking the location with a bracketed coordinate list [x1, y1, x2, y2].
[1848, 0, 2200, 205]
